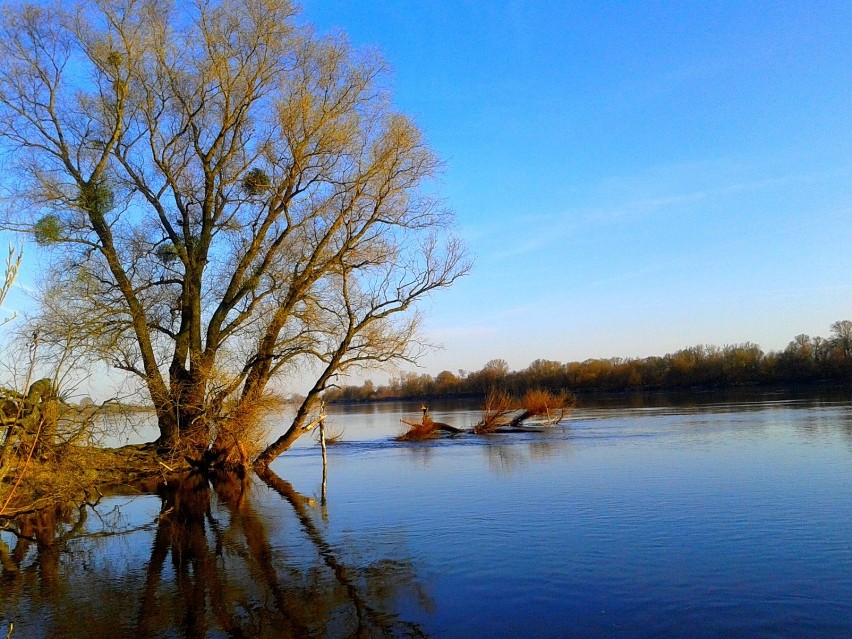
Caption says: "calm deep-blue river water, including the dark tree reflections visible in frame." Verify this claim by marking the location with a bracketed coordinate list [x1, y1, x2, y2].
[0, 400, 852, 639]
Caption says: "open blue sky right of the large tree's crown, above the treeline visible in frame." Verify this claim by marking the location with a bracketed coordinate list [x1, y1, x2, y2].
[302, 0, 852, 379]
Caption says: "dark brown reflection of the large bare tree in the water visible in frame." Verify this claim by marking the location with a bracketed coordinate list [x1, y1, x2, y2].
[0, 470, 431, 637]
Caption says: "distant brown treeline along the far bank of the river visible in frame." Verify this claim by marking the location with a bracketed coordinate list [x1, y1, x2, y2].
[325, 320, 852, 402]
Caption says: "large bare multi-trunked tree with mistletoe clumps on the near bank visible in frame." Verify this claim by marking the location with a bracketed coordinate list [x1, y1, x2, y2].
[0, 0, 469, 470]
